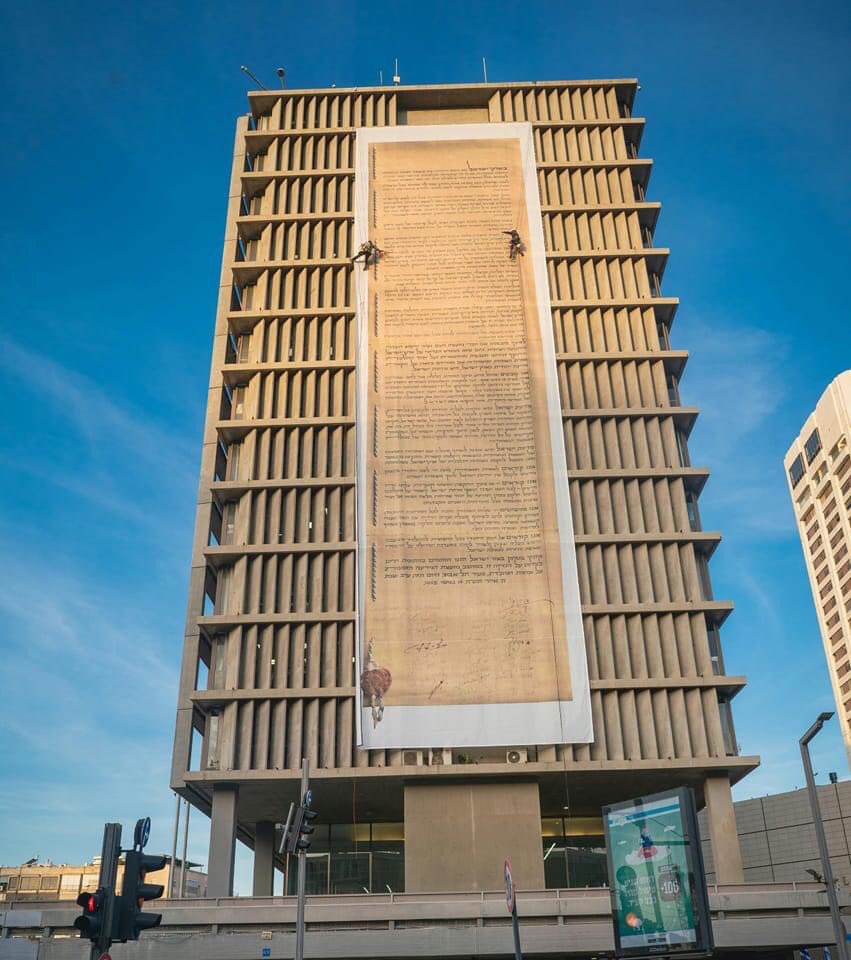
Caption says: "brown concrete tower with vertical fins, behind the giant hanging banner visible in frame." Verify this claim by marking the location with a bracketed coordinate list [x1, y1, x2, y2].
[172, 80, 758, 896]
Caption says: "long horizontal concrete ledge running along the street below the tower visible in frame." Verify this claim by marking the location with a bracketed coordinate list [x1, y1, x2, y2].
[0, 883, 830, 960]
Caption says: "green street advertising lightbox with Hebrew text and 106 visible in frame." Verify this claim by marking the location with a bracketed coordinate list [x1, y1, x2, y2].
[603, 787, 713, 957]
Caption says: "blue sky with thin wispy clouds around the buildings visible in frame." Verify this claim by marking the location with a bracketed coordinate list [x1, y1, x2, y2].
[0, 0, 851, 892]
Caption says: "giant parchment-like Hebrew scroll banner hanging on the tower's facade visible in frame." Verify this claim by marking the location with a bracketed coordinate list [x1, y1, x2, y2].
[355, 123, 592, 749]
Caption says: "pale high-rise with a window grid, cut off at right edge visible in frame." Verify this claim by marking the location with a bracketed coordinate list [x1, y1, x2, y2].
[784, 370, 851, 758]
